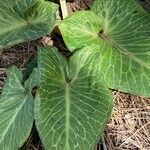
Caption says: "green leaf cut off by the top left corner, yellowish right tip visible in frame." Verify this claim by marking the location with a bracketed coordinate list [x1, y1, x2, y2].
[0, 0, 57, 49]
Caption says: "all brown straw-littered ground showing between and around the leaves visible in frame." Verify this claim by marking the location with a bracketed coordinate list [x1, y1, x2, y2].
[0, 0, 150, 150]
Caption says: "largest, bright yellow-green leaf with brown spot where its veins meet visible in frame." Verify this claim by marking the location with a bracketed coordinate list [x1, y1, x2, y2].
[59, 0, 150, 97]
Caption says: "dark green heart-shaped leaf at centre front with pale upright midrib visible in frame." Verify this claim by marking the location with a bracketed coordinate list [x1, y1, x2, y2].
[36, 48, 112, 150]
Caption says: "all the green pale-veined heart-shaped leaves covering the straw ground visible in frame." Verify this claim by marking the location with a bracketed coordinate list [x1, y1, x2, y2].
[0, 0, 150, 150]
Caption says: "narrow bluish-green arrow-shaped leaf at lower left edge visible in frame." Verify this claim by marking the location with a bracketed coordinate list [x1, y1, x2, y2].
[0, 66, 37, 150]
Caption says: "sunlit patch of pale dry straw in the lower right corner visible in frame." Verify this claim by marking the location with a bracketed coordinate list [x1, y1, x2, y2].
[104, 91, 150, 150]
